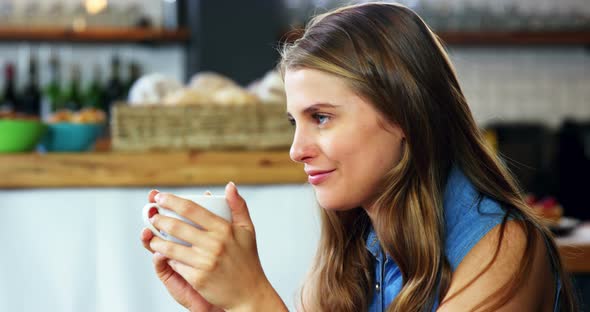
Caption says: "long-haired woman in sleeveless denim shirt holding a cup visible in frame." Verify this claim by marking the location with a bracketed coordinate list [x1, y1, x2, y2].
[142, 3, 576, 311]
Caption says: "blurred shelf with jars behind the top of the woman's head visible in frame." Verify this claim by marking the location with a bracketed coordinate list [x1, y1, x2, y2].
[282, 0, 590, 46]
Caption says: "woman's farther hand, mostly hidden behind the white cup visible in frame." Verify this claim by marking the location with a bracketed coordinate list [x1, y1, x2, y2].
[141, 190, 222, 312]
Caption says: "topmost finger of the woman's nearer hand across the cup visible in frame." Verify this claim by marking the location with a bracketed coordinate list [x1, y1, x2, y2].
[154, 193, 227, 230]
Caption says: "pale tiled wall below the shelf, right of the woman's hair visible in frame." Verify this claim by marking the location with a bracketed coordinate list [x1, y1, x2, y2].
[450, 47, 590, 127]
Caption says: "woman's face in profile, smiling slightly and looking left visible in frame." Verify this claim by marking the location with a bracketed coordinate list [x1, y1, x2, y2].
[285, 69, 404, 210]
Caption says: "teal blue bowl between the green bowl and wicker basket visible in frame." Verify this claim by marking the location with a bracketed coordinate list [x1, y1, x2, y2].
[41, 122, 104, 152]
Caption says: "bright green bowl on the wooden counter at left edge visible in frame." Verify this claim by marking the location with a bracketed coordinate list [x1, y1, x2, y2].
[0, 119, 47, 153]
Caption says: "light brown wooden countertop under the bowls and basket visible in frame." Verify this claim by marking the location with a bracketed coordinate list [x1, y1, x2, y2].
[0, 151, 307, 189]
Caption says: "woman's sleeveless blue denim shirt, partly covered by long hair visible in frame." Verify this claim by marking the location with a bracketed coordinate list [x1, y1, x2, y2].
[367, 167, 561, 312]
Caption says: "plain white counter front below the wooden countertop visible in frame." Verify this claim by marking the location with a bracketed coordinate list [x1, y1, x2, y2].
[0, 185, 319, 312]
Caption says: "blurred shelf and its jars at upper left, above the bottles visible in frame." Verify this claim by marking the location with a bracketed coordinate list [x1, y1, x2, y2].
[0, 0, 189, 43]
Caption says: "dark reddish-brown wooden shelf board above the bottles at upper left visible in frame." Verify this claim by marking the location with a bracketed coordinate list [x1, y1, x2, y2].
[0, 27, 189, 43]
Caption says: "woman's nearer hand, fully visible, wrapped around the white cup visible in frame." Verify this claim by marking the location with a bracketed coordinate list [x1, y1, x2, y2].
[149, 182, 287, 311]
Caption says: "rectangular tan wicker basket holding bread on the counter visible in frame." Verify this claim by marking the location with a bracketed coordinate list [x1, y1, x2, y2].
[111, 103, 293, 151]
